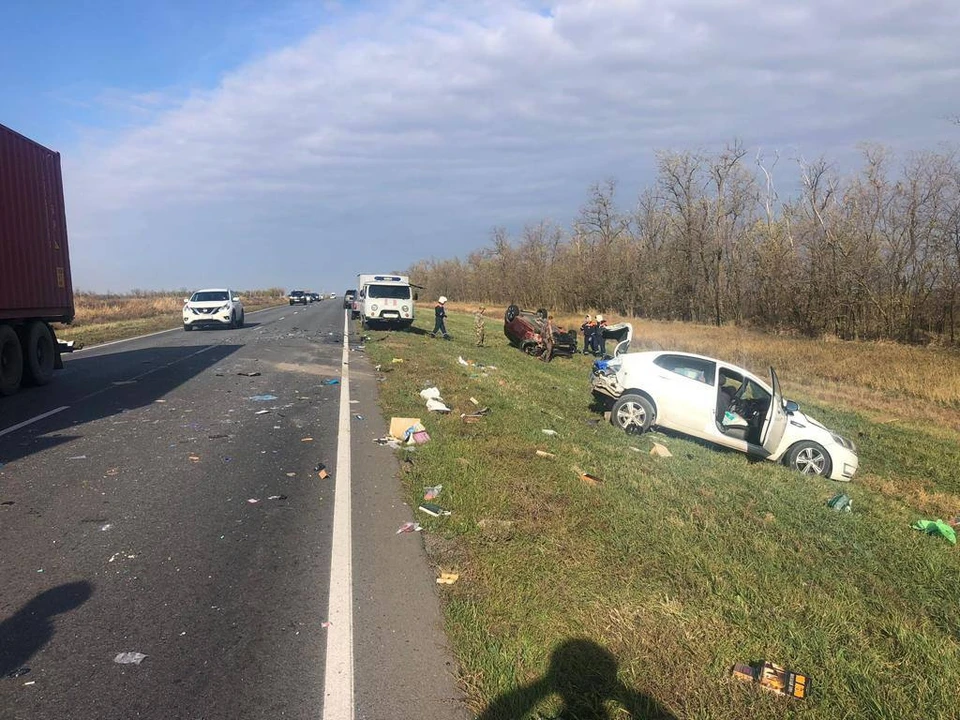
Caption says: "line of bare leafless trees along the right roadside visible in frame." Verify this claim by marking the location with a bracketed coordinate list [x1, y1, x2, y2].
[409, 143, 960, 344]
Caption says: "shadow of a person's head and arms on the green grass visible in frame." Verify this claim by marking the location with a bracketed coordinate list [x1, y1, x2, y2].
[478, 638, 676, 720]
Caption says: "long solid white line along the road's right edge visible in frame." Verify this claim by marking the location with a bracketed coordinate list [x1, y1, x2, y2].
[323, 313, 353, 720]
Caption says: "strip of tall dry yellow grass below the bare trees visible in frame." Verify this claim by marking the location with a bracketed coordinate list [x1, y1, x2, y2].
[440, 303, 960, 436]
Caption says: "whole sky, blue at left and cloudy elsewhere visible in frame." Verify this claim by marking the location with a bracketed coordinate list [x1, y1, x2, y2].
[0, 0, 960, 292]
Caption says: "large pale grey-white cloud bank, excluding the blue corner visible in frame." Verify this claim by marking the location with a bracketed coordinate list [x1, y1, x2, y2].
[65, 0, 960, 288]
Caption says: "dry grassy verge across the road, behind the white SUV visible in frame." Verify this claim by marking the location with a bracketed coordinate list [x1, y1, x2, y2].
[55, 291, 287, 346]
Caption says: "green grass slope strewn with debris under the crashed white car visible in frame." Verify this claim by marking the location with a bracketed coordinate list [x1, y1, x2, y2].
[366, 311, 960, 720]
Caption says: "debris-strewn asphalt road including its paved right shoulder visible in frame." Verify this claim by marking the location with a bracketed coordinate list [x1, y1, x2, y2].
[0, 301, 467, 720]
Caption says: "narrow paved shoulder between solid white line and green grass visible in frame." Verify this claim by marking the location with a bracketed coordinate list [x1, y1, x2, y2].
[350, 324, 471, 720]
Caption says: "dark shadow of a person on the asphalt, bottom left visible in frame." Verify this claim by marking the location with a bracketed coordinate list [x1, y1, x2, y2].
[0, 580, 93, 678]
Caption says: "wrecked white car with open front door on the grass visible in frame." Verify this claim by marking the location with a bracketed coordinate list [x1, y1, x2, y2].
[591, 351, 859, 481]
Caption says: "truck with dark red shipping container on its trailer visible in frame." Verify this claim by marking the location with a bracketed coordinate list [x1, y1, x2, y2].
[0, 125, 74, 395]
